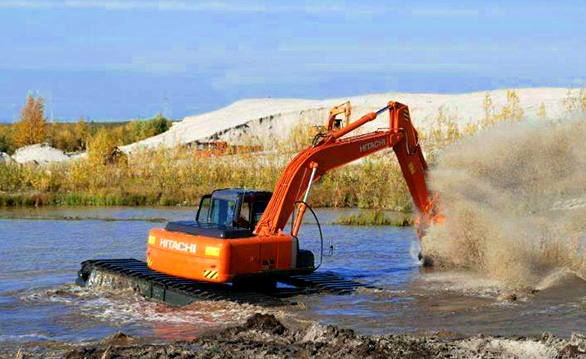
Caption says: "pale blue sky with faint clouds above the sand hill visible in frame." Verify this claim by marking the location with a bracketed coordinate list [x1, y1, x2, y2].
[0, 0, 586, 121]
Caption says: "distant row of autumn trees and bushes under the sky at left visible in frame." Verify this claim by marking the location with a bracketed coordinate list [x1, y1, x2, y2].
[0, 94, 171, 154]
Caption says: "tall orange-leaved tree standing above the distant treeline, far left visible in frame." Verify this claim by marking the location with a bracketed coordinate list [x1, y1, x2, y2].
[14, 94, 47, 147]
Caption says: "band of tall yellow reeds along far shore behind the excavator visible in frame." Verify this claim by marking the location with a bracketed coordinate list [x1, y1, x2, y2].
[0, 149, 410, 211]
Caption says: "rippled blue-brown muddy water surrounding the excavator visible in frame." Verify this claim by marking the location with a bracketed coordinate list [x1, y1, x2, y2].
[0, 208, 586, 343]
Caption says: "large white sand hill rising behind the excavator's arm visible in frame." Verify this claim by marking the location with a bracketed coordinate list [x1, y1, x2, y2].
[122, 88, 567, 152]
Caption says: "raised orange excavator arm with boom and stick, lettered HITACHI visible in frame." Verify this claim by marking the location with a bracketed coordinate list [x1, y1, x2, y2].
[255, 102, 438, 240]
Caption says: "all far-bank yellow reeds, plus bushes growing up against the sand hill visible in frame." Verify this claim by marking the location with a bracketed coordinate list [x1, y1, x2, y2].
[0, 90, 586, 210]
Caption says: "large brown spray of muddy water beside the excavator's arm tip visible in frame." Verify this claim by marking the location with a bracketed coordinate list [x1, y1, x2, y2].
[422, 119, 586, 288]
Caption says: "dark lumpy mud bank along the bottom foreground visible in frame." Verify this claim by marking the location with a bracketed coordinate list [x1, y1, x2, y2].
[0, 313, 586, 359]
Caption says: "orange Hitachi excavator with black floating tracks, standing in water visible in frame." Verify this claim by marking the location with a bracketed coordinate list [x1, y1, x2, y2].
[78, 101, 442, 302]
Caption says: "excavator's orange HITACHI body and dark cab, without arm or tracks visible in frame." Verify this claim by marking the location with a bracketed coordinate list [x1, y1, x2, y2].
[147, 188, 315, 283]
